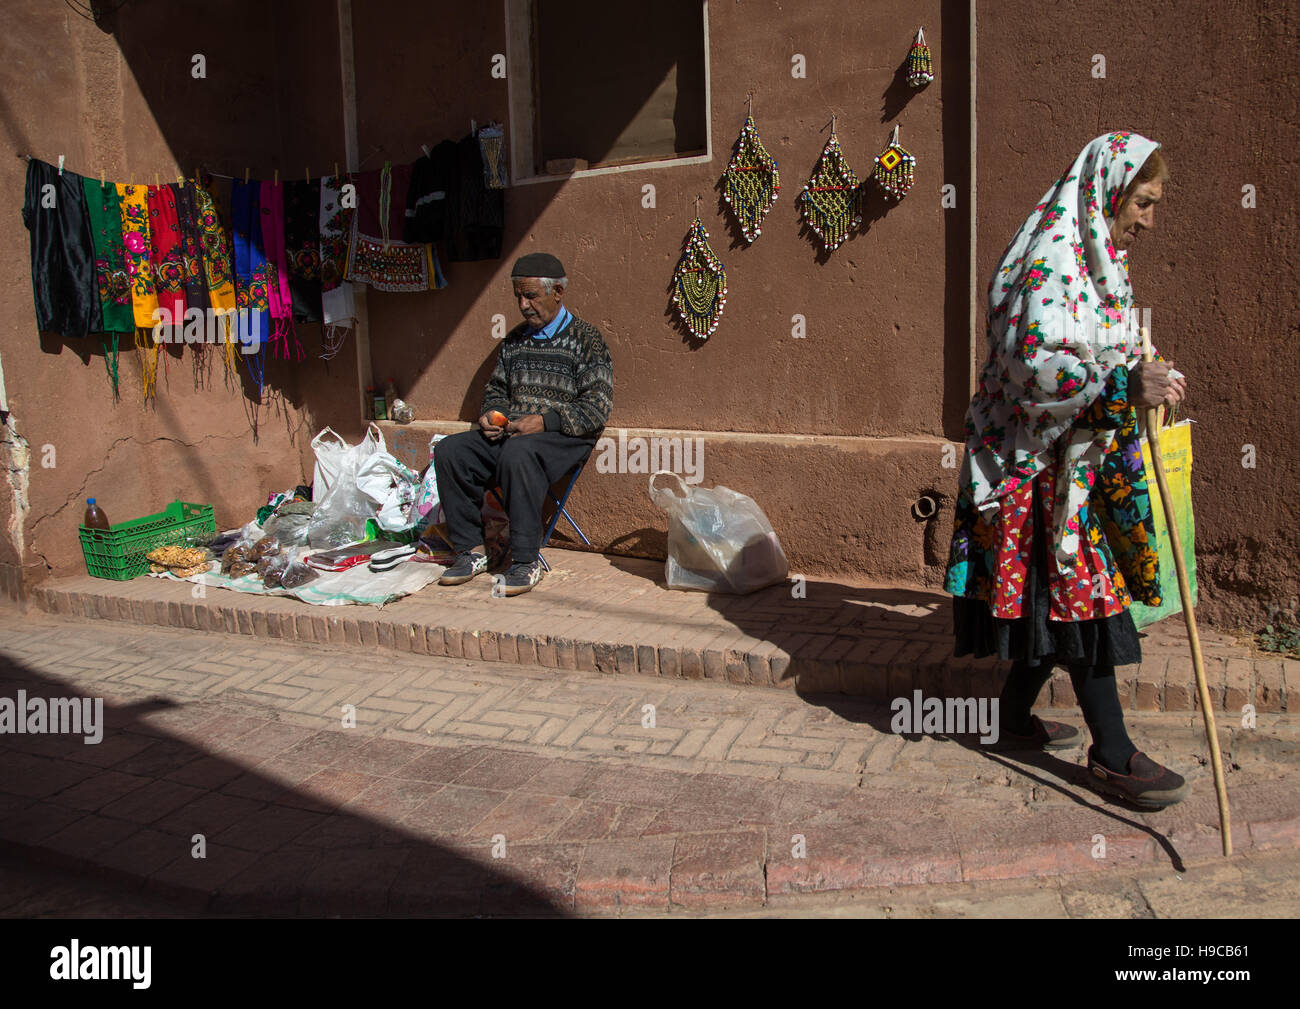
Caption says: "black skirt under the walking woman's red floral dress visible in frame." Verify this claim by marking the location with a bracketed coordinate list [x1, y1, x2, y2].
[953, 483, 1141, 666]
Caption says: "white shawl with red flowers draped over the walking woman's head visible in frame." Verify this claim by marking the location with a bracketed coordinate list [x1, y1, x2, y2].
[961, 133, 1158, 560]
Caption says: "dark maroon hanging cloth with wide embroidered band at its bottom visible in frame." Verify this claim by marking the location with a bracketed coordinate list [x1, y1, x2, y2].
[347, 161, 433, 291]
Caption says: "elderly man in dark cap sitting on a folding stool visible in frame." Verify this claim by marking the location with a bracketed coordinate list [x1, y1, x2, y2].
[433, 252, 614, 596]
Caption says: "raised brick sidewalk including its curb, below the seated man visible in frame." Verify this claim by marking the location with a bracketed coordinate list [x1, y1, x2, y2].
[20, 550, 1300, 707]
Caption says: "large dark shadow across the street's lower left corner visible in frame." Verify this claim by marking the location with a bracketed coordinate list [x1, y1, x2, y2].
[0, 658, 566, 917]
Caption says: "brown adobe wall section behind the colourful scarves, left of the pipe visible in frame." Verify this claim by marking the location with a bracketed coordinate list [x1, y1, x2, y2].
[0, 0, 360, 597]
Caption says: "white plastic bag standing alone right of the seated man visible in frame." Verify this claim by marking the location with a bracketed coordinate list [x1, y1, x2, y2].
[650, 469, 789, 596]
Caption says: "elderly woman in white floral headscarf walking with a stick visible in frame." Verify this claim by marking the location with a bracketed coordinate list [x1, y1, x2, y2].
[945, 133, 1187, 809]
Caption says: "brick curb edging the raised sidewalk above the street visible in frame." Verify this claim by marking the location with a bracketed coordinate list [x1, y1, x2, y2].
[33, 554, 1300, 715]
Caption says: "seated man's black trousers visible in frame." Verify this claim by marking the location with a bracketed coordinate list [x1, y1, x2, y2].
[433, 428, 595, 564]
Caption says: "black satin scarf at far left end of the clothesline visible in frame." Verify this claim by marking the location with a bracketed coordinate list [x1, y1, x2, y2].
[22, 157, 104, 337]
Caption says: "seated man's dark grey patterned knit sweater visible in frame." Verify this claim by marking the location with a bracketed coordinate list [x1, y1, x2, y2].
[478, 316, 614, 438]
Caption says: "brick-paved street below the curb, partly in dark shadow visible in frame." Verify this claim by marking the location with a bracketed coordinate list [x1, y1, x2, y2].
[0, 610, 1300, 914]
